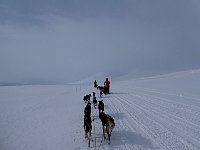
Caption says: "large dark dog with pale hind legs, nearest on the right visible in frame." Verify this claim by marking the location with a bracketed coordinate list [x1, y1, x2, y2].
[99, 112, 115, 144]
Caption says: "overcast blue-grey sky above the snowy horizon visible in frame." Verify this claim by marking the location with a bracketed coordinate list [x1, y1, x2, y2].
[0, 0, 200, 83]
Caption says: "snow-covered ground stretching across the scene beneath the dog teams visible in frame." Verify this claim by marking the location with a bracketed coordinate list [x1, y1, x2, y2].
[0, 70, 200, 150]
